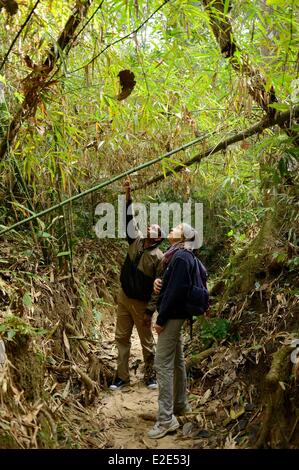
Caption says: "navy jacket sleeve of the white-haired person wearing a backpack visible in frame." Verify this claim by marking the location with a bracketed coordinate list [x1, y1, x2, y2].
[156, 257, 191, 326]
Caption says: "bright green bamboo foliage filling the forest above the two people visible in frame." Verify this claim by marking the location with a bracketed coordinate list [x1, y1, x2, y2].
[0, 0, 299, 272]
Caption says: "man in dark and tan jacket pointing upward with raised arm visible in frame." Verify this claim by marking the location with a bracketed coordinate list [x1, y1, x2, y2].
[110, 181, 163, 390]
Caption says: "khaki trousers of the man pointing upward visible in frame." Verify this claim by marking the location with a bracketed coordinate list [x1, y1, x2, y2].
[115, 290, 155, 381]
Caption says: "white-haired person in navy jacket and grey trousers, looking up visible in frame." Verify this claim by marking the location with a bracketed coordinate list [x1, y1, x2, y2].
[148, 224, 207, 439]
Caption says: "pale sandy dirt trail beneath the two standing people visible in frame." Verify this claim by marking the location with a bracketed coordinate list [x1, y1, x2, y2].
[98, 316, 192, 449]
